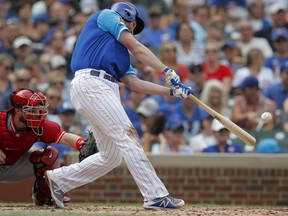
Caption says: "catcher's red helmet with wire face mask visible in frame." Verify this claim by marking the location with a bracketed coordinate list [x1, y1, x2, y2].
[10, 89, 48, 136]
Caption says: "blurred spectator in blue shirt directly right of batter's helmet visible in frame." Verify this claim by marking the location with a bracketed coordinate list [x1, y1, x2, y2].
[138, 5, 175, 53]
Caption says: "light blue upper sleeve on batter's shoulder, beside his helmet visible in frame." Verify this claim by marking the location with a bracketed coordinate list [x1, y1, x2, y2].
[97, 9, 130, 40]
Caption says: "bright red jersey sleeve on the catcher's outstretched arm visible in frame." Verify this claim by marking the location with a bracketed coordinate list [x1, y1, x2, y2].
[40, 121, 65, 143]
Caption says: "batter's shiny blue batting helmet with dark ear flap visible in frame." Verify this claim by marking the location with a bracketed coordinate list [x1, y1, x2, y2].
[111, 2, 144, 34]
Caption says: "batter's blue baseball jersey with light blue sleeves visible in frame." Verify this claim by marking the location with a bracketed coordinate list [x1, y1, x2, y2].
[71, 9, 136, 80]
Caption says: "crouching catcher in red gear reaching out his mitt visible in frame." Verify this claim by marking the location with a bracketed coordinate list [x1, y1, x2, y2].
[0, 89, 97, 205]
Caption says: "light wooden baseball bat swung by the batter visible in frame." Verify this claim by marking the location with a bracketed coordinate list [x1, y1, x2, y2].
[188, 94, 256, 146]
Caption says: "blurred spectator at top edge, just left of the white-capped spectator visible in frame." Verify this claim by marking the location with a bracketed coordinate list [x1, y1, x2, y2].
[248, 0, 271, 32]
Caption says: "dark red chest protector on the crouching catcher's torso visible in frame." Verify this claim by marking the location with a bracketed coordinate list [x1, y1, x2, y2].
[0, 112, 38, 165]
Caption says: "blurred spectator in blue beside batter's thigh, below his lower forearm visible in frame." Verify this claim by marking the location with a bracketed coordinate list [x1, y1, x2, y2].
[123, 90, 146, 138]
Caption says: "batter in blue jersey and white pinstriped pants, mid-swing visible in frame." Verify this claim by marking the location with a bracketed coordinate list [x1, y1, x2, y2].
[45, 2, 191, 208]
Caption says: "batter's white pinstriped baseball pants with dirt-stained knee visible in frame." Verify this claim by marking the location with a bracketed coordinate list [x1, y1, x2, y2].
[53, 69, 168, 201]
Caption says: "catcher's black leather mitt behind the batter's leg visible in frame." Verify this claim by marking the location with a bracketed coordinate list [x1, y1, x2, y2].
[79, 131, 99, 162]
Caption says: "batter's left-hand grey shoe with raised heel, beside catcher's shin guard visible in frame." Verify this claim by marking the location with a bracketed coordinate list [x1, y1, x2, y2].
[44, 171, 64, 208]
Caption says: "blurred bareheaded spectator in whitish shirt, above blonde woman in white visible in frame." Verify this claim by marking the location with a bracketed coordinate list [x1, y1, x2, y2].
[238, 19, 273, 58]
